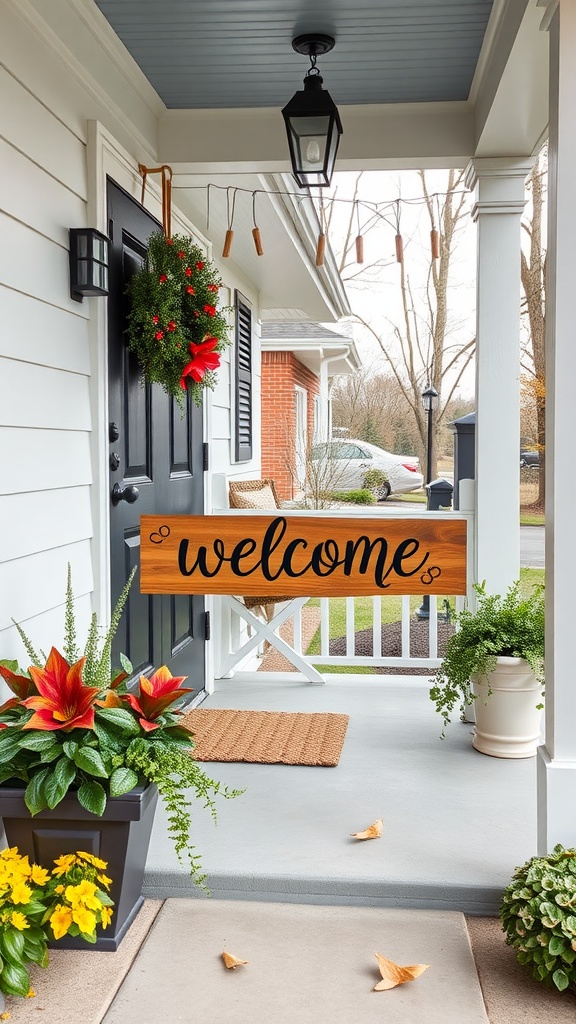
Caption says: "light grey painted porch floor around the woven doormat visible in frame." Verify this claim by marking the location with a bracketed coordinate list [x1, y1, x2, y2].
[145, 672, 536, 914]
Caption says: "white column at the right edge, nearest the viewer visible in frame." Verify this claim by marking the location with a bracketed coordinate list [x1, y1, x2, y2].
[538, 0, 576, 854]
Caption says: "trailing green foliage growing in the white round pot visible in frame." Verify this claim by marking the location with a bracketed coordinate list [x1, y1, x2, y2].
[430, 581, 544, 736]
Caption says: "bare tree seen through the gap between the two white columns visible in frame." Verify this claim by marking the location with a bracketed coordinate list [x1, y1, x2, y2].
[521, 146, 547, 505]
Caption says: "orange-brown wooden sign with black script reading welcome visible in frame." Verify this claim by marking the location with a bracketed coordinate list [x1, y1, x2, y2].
[140, 513, 466, 597]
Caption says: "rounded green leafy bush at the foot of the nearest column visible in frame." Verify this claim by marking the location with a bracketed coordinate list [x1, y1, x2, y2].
[500, 845, 576, 992]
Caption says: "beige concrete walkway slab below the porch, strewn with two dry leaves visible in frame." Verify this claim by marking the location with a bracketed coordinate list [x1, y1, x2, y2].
[104, 900, 488, 1024]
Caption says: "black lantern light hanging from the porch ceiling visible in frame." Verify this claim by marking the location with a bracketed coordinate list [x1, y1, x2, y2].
[282, 33, 342, 188]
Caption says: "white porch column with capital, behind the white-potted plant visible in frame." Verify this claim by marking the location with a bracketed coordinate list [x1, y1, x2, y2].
[466, 157, 533, 594]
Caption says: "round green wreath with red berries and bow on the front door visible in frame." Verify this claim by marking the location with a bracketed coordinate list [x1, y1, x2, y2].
[126, 231, 230, 407]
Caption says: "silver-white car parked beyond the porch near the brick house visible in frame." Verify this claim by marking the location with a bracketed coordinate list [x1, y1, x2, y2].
[311, 437, 424, 502]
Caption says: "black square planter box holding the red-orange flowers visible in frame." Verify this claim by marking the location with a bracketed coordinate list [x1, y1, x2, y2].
[0, 785, 158, 952]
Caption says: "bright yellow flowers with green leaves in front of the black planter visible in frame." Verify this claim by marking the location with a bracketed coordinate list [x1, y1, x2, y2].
[0, 847, 114, 996]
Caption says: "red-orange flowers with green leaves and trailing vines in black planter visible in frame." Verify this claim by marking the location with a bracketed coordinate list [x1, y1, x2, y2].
[0, 566, 240, 884]
